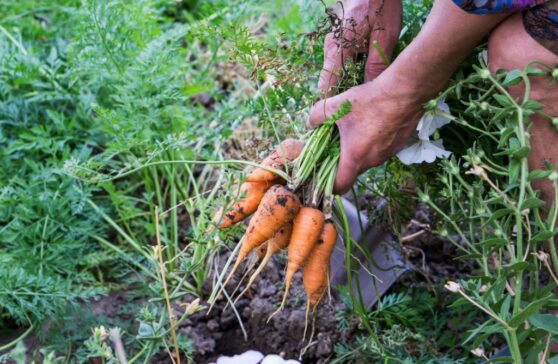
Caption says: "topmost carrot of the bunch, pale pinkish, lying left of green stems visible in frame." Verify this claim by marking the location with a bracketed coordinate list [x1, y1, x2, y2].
[246, 139, 304, 182]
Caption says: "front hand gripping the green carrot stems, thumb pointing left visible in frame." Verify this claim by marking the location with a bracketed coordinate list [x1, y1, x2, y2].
[308, 72, 423, 193]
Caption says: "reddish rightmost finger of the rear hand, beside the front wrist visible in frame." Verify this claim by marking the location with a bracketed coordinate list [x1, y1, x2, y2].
[364, 1, 402, 82]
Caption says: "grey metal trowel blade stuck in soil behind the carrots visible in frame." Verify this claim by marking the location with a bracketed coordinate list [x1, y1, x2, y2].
[330, 198, 410, 307]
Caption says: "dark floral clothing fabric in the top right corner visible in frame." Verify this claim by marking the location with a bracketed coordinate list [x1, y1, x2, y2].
[453, 0, 558, 54]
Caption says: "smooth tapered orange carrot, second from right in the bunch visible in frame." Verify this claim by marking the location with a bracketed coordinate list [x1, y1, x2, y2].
[279, 207, 325, 310]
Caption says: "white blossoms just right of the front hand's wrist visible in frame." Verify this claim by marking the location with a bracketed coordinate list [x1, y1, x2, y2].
[397, 100, 451, 165]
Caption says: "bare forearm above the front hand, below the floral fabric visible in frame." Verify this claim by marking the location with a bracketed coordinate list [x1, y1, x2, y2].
[392, 0, 510, 102]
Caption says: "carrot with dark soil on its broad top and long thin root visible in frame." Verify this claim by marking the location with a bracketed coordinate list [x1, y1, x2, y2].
[209, 185, 300, 310]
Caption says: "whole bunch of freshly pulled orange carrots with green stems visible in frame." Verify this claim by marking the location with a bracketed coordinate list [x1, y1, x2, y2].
[208, 103, 350, 330]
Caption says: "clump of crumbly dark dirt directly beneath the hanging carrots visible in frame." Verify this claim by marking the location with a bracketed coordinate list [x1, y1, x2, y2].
[179, 253, 358, 363]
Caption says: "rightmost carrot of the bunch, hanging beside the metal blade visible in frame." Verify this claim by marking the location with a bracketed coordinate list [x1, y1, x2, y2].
[302, 221, 337, 307]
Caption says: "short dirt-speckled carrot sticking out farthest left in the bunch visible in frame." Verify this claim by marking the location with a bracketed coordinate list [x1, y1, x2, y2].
[214, 182, 272, 229]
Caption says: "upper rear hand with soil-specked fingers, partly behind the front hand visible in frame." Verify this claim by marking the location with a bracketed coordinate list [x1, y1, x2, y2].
[318, 0, 402, 96]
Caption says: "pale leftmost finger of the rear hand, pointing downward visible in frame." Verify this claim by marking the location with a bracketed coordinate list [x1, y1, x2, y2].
[318, 33, 355, 97]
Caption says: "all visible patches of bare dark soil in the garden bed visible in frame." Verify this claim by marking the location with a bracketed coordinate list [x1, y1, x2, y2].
[0, 202, 482, 364]
